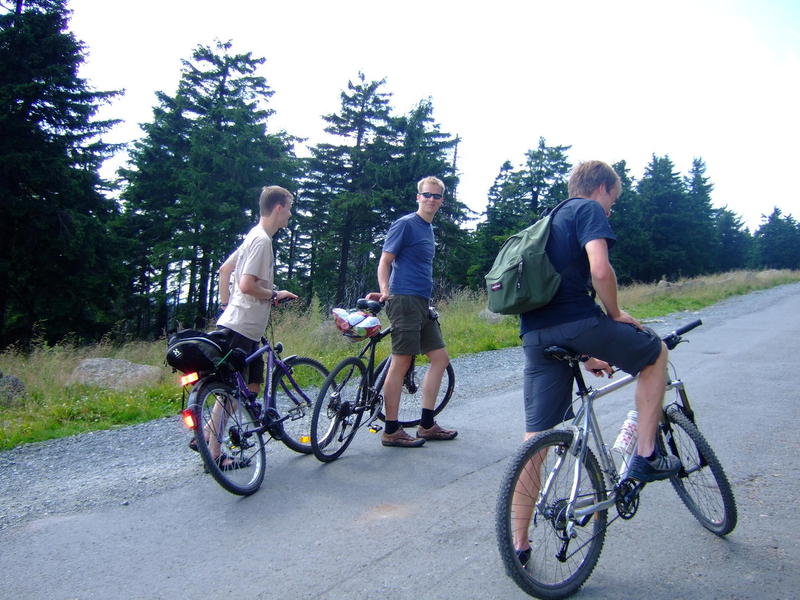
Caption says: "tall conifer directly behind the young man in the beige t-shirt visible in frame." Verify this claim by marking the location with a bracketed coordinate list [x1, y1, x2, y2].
[121, 42, 299, 328]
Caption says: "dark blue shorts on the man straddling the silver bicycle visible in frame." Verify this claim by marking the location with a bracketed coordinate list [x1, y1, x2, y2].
[522, 315, 661, 432]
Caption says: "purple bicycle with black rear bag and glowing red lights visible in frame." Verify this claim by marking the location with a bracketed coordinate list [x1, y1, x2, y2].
[173, 332, 328, 496]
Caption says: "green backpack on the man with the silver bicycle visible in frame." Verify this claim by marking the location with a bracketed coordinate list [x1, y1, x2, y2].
[484, 199, 569, 315]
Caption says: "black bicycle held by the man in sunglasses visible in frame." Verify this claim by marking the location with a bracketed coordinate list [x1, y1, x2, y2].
[311, 298, 456, 462]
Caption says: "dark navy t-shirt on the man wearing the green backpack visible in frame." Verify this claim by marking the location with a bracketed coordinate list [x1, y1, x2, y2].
[520, 198, 617, 335]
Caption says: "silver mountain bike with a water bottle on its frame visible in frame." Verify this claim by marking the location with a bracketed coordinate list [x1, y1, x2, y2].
[496, 320, 737, 599]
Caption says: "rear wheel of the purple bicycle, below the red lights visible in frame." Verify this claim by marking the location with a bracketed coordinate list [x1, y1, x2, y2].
[191, 381, 267, 496]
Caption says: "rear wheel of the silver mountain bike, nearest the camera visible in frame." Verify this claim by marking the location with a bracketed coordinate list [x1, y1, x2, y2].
[495, 430, 608, 599]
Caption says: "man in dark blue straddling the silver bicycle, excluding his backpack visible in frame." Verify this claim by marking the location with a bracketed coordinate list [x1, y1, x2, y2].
[515, 160, 680, 564]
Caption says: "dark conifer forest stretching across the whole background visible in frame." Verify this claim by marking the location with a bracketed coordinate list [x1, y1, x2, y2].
[0, 0, 800, 348]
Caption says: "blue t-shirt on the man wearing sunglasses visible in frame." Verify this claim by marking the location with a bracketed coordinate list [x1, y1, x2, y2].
[383, 213, 436, 298]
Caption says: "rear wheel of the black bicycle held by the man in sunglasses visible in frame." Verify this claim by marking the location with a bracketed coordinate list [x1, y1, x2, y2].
[311, 356, 367, 462]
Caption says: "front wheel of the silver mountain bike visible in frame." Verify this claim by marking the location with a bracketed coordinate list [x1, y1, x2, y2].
[659, 404, 738, 536]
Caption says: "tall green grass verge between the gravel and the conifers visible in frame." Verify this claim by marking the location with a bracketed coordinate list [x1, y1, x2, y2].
[0, 270, 800, 450]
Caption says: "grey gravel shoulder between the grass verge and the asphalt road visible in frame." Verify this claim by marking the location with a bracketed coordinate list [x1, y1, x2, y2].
[0, 283, 800, 530]
